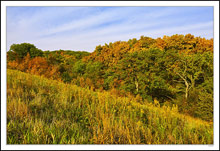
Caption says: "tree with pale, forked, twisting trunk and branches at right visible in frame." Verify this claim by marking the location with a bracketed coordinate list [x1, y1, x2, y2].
[166, 52, 211, 100]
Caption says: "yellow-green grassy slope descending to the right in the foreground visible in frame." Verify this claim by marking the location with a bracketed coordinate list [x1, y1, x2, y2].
[7, 69, 213, 144]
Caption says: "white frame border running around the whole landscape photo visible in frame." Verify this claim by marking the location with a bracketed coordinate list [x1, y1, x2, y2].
[1, 1, 219, 150]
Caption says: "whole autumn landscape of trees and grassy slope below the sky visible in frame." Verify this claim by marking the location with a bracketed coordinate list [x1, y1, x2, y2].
[7, 34, 213, 144]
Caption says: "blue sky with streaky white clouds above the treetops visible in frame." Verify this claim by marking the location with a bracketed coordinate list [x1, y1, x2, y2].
[7, 6, 214, 52]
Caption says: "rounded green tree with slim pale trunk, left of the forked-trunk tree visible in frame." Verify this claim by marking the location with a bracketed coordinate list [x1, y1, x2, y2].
[117, 49, 173, 102]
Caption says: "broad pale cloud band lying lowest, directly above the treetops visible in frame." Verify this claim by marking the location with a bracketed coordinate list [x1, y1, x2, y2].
[26, 22, 213, 52]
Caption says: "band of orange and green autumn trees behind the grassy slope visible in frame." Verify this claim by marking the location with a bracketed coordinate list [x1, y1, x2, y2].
[7, 34, 213, 122]
